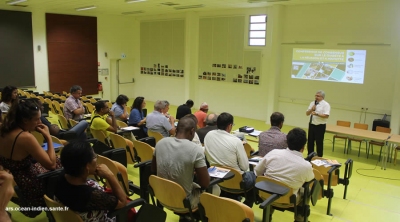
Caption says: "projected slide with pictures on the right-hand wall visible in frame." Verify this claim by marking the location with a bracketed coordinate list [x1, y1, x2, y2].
[291, 48, 366, 84]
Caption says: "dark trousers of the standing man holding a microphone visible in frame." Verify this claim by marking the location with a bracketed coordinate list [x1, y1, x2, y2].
[307, 124, 326, 157]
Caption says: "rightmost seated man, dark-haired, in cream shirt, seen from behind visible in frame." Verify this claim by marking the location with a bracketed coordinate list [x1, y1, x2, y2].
[254, 128, 314, 222]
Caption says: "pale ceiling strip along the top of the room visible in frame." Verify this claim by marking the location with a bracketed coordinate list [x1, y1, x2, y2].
[0, 0, 384, 16]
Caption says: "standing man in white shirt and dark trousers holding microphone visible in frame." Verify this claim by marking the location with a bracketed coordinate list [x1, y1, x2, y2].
[306, 90, 331, 157]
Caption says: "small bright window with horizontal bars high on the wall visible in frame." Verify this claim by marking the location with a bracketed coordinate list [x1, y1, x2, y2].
[249, 15, 267, 46]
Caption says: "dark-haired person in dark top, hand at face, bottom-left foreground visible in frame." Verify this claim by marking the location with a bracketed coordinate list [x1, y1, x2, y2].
[55, 141, 126, 221]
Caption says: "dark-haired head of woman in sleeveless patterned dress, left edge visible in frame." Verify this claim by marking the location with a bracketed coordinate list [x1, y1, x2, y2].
[0, 100, 42, 136]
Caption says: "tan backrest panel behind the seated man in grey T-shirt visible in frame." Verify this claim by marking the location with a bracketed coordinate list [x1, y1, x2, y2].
[149, 175, 187, 211]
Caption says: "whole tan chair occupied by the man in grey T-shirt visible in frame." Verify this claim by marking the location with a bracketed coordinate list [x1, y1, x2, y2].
[149, 175, 198, 221]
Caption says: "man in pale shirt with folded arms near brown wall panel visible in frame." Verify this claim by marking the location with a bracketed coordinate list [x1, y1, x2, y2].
[63, 85, 85, 121]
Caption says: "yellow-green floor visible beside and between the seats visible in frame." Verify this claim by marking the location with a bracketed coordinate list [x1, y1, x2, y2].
[9, 102, 400, 222]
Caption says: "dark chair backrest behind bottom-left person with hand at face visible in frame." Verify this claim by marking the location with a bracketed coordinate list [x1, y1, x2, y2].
[44, 195, 83, 222]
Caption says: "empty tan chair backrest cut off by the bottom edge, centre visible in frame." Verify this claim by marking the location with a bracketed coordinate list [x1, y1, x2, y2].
[200, 192, 254, 222]
